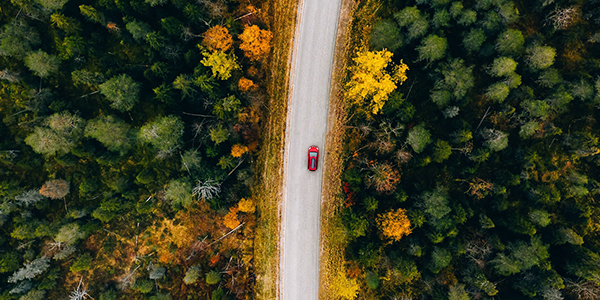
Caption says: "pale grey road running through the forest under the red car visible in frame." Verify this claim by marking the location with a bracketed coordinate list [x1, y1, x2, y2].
[279, 0, 341, 300]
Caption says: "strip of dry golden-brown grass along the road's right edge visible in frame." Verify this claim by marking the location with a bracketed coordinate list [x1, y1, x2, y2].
[319, 0, 380, 299]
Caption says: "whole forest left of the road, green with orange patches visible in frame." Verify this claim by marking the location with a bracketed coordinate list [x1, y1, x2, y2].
[0, 0, 273, 300]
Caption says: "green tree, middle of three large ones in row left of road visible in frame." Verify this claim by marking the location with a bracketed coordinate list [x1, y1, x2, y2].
[85, 116, 133, 153]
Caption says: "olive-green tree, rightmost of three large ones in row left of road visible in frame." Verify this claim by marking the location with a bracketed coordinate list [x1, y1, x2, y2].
[138, 116, 184, 151]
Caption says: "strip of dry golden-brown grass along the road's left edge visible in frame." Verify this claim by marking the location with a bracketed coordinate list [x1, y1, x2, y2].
[253, 0, 298, 300]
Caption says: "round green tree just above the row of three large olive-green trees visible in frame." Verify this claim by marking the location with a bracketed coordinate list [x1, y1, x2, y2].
[99, 74, 141, 111]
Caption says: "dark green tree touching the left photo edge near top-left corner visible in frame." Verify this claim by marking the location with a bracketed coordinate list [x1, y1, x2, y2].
[0, 19, 40, 59]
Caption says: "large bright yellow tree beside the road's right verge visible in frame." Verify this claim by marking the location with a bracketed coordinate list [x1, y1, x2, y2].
[346, 49, 408, 114]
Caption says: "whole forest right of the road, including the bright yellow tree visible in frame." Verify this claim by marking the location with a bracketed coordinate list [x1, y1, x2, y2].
[332, 0, 600, 300]
